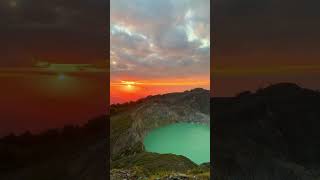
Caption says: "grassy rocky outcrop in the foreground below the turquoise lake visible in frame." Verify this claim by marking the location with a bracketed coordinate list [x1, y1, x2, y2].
[110, 152, 210, 180]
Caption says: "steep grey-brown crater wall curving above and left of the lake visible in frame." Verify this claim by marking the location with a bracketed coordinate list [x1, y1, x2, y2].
[111, 90, 210, 157]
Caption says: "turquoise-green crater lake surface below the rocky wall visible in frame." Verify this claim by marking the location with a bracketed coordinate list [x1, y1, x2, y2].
[144, 123, 210, 164]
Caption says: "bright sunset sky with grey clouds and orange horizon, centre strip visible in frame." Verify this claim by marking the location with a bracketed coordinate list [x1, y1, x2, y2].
[110, 0, 210, 103]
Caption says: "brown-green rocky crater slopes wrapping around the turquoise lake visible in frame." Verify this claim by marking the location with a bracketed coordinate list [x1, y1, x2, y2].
[110, 89, 210, 178]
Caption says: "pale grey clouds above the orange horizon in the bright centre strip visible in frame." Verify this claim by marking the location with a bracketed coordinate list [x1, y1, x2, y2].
[111, 0, 210, 78]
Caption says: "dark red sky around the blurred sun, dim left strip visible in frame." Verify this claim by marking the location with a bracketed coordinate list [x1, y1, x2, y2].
[0, 65, 107, 136]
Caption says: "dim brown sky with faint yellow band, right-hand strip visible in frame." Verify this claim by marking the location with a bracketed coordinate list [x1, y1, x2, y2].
[211, 0, 320, 96]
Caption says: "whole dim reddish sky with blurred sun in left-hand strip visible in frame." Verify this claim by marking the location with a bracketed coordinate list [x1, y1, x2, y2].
[0, 0, 108, 136]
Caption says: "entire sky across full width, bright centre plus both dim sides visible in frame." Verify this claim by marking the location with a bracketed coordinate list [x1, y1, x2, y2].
[0, 0, 320, 136]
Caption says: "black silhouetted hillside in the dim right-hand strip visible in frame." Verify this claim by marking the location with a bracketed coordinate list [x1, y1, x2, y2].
[211, 83, 320, 180]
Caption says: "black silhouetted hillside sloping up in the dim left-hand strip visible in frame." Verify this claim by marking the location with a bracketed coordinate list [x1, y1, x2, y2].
[0, 116, 107, 180]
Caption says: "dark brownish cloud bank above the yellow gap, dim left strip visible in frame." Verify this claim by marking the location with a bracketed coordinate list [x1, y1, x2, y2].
[0, 0, 109, 66]
